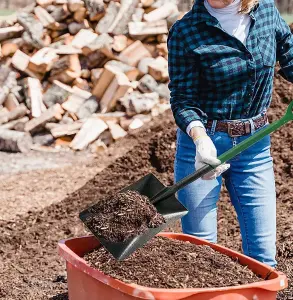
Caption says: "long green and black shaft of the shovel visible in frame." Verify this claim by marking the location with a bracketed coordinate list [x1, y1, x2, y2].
[152, 101, 293, 203]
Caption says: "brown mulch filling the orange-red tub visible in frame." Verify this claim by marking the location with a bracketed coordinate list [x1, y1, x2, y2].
[84, 237, 262, 289]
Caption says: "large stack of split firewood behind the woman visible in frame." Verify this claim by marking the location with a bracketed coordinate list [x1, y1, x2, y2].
[0, 0, 182, 152]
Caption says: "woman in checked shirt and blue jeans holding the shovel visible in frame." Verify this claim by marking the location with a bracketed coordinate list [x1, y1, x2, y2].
[168, 0, 293, 266]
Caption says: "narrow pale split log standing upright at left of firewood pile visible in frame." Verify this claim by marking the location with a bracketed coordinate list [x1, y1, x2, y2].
[26, 77, 46, 118]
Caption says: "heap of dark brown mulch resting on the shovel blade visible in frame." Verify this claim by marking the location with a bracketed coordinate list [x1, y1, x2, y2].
[85, 191, 165, 242]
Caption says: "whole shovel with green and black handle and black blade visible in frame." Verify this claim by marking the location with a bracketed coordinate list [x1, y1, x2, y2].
[80, 101, 293, 260]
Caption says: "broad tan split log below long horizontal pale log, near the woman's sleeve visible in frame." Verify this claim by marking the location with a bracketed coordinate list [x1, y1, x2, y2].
[118, 41, 151, 67]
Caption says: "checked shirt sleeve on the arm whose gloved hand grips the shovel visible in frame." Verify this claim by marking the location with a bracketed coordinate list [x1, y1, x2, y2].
[168, 23, 207, 132]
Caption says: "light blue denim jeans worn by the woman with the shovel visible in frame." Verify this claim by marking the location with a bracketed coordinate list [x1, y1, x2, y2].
[175, 120, 276, 267]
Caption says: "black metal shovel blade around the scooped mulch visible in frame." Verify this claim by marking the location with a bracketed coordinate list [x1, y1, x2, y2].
[79, 173, 188, 260]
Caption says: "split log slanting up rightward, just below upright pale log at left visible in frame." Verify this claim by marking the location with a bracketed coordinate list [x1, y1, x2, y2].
[24, 104, 64, 133]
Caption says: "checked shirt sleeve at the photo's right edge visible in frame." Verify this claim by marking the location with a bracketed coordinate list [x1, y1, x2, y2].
[275, 8, 293, 82]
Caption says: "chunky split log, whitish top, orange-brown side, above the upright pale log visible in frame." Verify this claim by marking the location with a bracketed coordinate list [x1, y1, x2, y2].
[28, 47, 59, 73]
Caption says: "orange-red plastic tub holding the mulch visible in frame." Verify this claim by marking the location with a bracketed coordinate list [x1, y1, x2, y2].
[58, 232, 288, 300]
